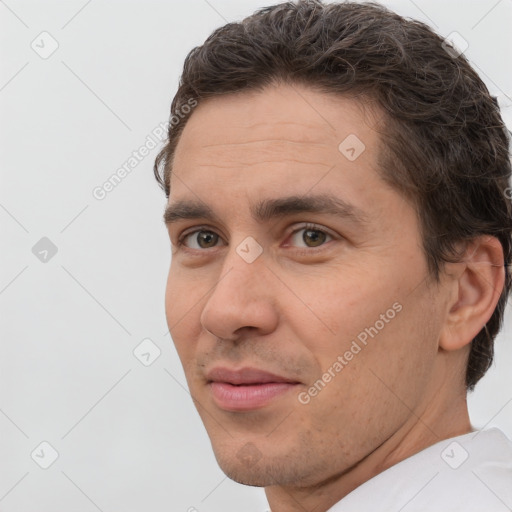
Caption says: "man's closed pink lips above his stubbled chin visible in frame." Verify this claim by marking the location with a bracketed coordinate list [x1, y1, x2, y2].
[206, 367, 300, 411]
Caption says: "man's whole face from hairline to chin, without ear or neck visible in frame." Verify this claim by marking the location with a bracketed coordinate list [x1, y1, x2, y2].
[166, 85, 443, 486]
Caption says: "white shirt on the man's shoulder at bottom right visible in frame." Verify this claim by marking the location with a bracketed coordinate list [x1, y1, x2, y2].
[328, 428, 512, 512]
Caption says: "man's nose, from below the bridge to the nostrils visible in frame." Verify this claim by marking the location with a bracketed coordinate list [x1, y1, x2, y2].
[200, 248, 279, 341]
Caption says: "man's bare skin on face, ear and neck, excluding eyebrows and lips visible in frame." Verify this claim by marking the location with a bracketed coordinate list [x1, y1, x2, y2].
[166, 84, 504, 512]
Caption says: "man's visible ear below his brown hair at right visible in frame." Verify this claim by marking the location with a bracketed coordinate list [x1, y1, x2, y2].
[439, 235, 505, 350]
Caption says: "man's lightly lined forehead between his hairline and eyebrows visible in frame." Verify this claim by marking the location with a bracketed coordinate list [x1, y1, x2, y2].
[169, 85, 386, 209]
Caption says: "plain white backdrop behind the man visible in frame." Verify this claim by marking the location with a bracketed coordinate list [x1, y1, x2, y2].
[0, 0, 512, 512]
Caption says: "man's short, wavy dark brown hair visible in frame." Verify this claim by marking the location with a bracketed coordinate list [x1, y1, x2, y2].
[154, 0, 512, 390]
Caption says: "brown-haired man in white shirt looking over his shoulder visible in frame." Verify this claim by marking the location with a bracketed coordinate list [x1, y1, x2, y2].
[155, 1, 512, 512]
